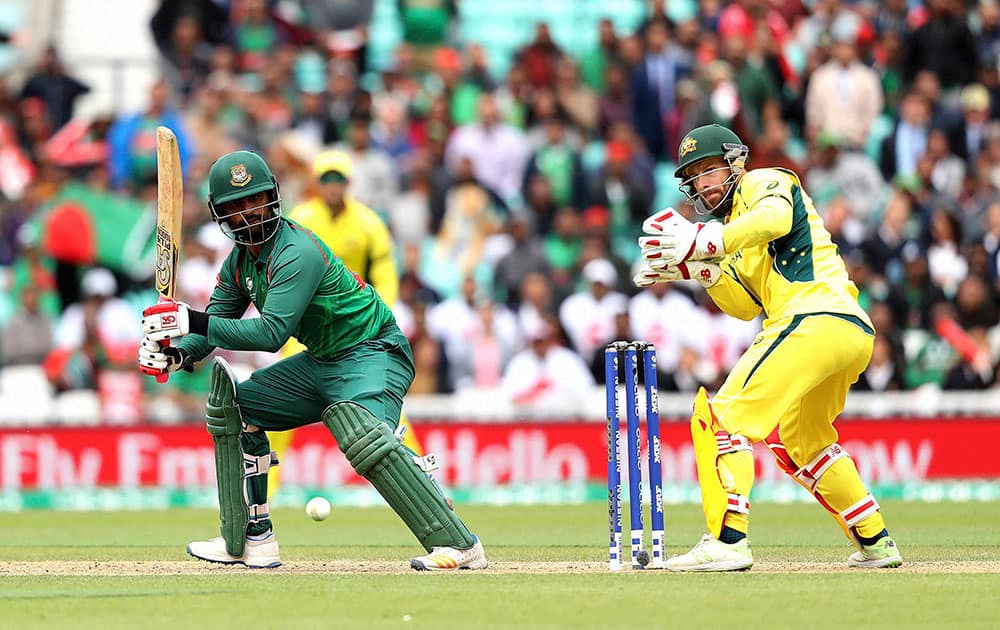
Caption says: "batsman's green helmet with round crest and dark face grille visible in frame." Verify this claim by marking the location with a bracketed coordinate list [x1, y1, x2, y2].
[208, 151, 281, 245]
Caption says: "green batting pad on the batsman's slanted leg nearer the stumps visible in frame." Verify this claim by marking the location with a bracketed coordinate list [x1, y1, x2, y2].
[323, 401, 475, 551]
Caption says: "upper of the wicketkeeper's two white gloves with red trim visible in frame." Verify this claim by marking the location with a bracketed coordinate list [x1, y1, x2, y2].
[639, 208, 726, 266]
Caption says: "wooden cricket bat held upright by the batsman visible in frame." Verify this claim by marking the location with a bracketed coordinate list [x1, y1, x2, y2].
[156, 127, 184, 383]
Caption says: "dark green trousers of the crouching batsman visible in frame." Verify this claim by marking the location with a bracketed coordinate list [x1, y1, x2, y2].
[236, 324, 414, 535]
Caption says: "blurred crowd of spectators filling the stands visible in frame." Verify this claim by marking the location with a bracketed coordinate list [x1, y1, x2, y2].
[0, 0, 1000, 424]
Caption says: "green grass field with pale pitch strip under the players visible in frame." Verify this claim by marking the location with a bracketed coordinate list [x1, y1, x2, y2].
[0, 502, 1000, 630]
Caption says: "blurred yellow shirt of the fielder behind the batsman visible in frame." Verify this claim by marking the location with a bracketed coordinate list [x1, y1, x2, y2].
[289, 198, 399, 308]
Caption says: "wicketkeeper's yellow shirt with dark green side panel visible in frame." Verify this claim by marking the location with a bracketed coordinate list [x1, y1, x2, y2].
[708, 168, 872, 326]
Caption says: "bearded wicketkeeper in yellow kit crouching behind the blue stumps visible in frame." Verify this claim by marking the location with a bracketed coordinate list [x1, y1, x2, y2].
[635, 125, 903, 571]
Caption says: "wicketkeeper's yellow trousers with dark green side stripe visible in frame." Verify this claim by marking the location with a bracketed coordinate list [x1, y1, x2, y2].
[712, 313, 884, 537]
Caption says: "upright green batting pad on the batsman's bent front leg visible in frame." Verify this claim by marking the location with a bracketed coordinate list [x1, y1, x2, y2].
[205, 357, 250, 558]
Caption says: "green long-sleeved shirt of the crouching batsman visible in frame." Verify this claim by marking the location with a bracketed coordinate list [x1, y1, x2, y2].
[178, 219, 395, 361]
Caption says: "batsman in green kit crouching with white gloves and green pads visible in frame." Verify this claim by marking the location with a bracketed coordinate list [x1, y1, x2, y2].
[139, 151, 487, 570]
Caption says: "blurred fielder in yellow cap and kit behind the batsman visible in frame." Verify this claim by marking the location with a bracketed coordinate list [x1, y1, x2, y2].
[270, 151, 423, 495]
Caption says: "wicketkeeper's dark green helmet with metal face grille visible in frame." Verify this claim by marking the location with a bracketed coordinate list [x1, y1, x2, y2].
[674, 124, 750, 216]
